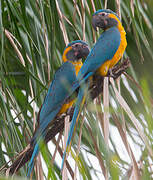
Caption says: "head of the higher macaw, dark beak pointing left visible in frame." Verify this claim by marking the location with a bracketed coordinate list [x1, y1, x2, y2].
[92, 9, 120, 31]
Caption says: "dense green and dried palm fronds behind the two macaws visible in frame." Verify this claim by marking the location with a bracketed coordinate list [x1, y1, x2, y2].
[0, 0, 153, 180]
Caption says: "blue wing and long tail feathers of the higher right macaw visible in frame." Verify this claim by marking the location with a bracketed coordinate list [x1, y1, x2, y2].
[61, 27, 121, 169]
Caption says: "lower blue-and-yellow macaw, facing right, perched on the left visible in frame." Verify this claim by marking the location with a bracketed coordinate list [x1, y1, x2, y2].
[27, 40, 89, 176]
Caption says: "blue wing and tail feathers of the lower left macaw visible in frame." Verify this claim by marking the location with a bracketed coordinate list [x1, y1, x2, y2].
[28, 62, 76, 176]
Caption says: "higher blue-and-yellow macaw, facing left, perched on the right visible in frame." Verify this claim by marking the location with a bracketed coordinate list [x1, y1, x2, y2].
[62, 9, 127, 169]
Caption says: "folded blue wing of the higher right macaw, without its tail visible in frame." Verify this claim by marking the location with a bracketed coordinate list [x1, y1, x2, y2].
[77, 27, 121, 81]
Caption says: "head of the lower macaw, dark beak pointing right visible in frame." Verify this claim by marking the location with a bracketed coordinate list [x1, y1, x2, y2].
[63, 40, 89, 62]
